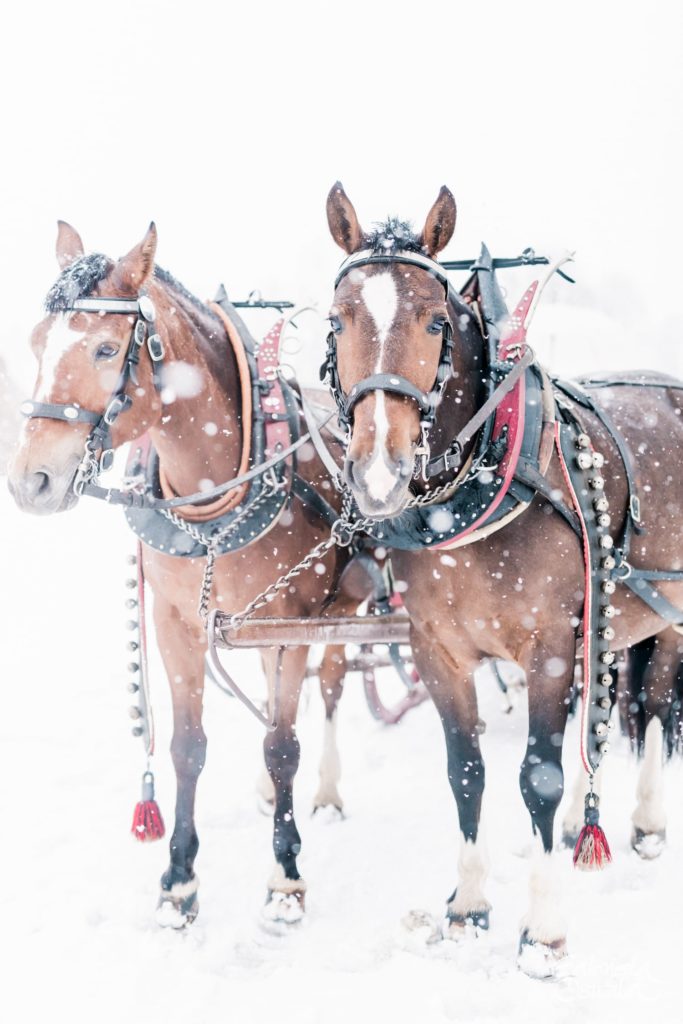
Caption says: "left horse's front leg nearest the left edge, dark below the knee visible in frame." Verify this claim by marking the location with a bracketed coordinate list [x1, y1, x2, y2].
[155, 598, 206, 928]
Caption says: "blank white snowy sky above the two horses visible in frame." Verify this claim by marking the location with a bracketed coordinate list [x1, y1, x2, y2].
[0, 0, 683, 388]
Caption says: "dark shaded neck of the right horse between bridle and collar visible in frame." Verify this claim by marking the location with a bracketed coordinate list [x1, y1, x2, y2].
[431, 300, 486, 455]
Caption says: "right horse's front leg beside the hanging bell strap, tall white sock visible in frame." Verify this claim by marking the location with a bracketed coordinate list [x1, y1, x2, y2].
[519, 634, 575, 977]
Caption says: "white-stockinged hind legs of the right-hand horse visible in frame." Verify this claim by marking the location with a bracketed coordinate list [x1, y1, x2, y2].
[562, 627, 683, 860]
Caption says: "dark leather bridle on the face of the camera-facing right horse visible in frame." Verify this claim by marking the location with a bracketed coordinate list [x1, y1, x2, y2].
[321, 249, 453, 476]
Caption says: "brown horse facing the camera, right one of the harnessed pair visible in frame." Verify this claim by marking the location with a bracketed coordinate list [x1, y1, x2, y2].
[322, 182, 683, 976]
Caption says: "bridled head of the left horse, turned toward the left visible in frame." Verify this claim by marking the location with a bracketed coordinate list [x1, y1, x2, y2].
[8, 221, 161, 514]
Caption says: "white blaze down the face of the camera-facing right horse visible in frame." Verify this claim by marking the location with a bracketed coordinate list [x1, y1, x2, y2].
[360, 271, 398, 502]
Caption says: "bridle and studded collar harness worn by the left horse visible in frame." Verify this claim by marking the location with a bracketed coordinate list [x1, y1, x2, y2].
[22, 289, 337, 558]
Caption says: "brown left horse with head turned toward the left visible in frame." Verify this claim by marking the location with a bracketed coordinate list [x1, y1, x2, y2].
[9, 223, 358, 927]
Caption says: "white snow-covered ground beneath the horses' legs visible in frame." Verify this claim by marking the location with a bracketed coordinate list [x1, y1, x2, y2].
[0, 488, 683, 1024]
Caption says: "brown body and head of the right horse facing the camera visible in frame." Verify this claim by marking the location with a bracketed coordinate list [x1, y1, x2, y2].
[327, 183, 683, 972]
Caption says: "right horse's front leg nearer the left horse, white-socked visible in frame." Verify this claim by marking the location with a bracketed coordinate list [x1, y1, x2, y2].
[412, 630, 490, 939]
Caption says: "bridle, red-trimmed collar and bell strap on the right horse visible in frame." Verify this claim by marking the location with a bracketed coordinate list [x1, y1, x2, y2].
[322, 239, 683, 782]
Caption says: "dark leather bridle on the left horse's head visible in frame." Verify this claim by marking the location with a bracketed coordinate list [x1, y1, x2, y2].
[22, 292, 164, 495]
